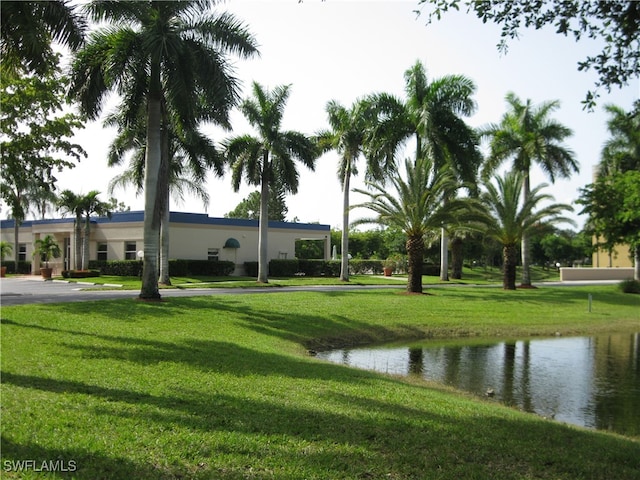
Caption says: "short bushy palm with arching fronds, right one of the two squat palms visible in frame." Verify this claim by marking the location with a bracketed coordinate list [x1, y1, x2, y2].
[480, 170, 574, 290]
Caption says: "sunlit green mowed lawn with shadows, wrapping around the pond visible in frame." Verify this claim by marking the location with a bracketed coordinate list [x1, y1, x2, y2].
[1, 286, 640, 480]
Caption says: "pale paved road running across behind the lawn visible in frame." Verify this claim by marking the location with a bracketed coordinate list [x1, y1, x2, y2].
[0, 276, 619, 306]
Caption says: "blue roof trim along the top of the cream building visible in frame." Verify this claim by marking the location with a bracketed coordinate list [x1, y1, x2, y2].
[0, 210, 331, 232]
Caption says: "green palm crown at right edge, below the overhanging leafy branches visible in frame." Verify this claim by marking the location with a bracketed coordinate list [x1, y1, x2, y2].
[598, 100, 640, 175]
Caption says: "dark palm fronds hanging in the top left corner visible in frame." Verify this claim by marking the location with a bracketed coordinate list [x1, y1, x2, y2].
[0, 0, 86, 75]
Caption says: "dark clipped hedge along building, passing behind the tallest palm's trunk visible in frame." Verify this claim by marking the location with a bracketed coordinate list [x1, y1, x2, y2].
[89, 260, 235, 277]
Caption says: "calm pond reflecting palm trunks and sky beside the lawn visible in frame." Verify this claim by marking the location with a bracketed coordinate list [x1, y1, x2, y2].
[317, 333, 640, 436]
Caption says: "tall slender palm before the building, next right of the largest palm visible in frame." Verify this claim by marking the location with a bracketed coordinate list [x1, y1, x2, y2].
[224, 82, 320, 283]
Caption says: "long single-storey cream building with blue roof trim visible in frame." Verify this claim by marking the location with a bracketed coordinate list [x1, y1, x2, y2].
[0, 211, 331, 275]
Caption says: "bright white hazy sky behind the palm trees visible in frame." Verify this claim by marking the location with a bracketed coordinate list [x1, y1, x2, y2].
[47, 0, 640, 229]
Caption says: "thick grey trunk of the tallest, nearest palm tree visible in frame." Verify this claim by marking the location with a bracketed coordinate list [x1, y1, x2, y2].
[139, 67, 162, 300]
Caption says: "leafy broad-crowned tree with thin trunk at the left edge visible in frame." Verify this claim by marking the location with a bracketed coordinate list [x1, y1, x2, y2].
[0, 68, 86, 271]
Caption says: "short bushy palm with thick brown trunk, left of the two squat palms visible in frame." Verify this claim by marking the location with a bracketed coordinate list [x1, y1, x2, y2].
[353, 156, 469, 293]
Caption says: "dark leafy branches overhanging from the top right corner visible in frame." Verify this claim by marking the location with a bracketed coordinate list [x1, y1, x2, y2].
[419, 0, 640, 107]
